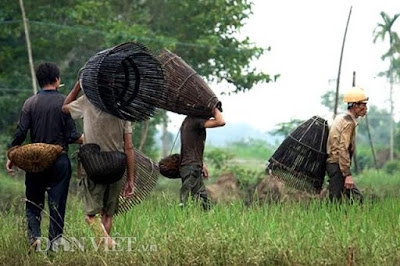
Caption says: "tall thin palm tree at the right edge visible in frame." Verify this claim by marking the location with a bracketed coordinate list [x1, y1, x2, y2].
[374, 12, 400, 160]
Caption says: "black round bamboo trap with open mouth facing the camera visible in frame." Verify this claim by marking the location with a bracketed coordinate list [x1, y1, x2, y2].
[79, 42, 165, 121]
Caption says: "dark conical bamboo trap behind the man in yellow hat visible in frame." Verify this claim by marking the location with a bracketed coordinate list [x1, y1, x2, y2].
[267, 116, 329, 193]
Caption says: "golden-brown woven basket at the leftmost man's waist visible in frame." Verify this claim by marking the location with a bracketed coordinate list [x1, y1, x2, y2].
[7, 143, 63, 173]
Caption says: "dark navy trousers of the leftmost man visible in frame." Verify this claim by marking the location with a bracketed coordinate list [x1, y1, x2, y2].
[25, 153, 71, 244]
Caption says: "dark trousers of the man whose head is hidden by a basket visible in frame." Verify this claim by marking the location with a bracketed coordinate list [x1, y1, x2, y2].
[179, 165, 210, 210]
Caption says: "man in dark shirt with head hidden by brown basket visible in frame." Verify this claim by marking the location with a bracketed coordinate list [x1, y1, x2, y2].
[179, 108, 225, 210]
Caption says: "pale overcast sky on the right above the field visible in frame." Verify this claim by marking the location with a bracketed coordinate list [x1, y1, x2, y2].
[170, 0, 400, 132]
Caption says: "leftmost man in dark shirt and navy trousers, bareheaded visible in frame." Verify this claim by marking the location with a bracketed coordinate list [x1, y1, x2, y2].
[6, 62, 82, 249]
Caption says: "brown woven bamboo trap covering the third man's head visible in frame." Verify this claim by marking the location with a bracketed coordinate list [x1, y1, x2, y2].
[158, 49, 221, 117]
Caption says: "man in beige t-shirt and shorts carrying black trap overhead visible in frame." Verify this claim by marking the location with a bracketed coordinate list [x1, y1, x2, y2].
[62, 82, 135, 247]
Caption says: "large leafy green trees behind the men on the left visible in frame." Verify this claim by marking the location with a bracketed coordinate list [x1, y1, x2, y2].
[0, 0, 271, 156]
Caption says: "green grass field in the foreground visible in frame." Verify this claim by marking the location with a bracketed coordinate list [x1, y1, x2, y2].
[0, 169, 400, 265]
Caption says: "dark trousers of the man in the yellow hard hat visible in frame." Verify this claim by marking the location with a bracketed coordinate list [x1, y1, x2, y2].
[326, 163, 364, 203]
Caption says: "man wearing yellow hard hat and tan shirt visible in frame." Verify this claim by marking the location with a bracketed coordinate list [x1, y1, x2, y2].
[326, 87, 368, 202]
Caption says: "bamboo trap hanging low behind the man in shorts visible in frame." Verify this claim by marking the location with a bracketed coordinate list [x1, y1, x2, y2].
[117, 149, 160, 214]
